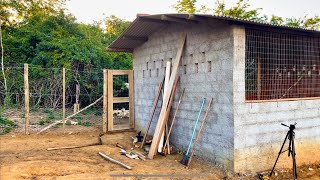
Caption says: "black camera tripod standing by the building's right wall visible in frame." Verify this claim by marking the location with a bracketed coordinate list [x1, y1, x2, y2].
[269, 123, 298, 180]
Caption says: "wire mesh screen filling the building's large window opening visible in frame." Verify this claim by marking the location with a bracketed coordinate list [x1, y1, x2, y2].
[245, 29, 320, 100]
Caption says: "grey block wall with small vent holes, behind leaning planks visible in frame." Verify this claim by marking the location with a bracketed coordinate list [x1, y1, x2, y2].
[133, 21, 234, 169]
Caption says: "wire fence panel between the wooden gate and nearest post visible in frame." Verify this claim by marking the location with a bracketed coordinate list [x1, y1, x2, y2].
[66, 69, 103, 132]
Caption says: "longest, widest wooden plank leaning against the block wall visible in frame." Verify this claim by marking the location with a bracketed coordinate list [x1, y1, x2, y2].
[148, 34, 186, 159]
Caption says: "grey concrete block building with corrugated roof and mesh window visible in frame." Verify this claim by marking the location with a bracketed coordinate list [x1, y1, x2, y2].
[108, 14, 320, 172]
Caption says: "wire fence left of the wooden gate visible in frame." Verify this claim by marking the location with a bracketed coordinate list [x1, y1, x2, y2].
[0, 65, 103, 134]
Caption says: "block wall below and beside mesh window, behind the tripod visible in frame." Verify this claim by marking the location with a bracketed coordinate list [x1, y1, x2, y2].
[232, 26, 320, 172]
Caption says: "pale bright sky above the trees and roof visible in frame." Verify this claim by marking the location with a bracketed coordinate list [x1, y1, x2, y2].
[67, 0, 320, 23]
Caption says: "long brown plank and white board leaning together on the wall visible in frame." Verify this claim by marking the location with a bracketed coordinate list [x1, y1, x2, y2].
[148, 34, 186, 159]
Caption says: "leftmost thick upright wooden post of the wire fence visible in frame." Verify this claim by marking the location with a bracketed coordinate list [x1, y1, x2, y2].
[24, 64, 29, 134]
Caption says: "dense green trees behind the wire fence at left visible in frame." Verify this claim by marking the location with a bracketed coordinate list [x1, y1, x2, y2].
[0, 0, 132, 107]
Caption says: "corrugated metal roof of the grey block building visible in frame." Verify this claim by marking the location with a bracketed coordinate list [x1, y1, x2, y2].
[107, 14, 320, 52]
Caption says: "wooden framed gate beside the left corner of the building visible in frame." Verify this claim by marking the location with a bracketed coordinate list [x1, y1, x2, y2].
[103, 70, 134, 132]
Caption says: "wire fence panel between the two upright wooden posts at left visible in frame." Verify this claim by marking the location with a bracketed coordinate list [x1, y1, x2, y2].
[28, 66, 62, 133]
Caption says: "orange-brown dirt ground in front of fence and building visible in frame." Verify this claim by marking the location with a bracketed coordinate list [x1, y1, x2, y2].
[0, 127, 320, 180]
